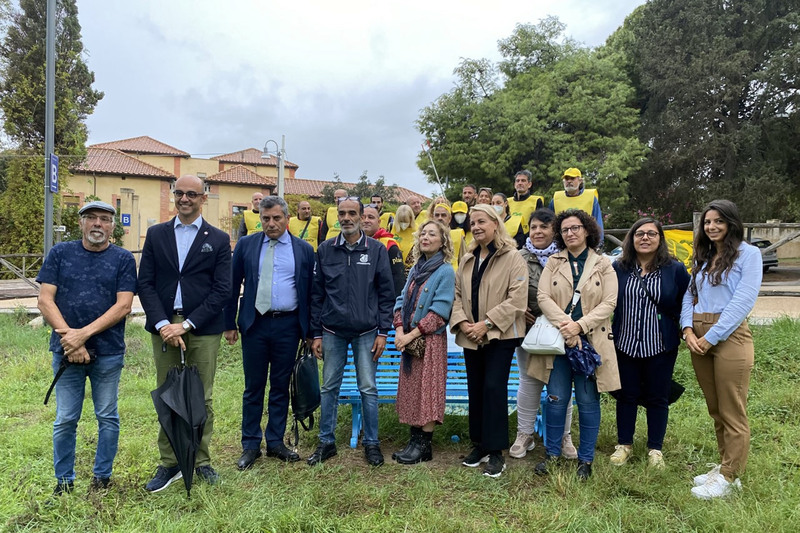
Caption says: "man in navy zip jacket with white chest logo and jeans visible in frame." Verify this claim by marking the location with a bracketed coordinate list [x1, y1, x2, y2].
[308, 197, 395, 466]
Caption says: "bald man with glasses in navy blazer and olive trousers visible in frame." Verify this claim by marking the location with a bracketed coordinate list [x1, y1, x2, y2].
[139, 176, 231, 492]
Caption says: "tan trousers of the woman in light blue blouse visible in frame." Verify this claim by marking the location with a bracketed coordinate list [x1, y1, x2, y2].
[692, 313, 755, 480]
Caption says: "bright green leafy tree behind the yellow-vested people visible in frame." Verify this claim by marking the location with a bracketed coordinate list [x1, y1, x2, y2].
[417, 18, 646, 223]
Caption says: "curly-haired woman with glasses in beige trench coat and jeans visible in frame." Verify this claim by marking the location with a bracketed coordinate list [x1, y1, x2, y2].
[534, 209, 620, 480]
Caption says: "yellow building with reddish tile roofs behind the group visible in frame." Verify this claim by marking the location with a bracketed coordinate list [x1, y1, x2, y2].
[67, 136, 432, 250]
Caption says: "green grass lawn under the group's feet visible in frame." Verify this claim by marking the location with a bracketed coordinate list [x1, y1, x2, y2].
[0, 315, 800, 533]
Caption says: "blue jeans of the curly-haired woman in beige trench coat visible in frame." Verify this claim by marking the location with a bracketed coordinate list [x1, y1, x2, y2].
[545, 355, 600, 463]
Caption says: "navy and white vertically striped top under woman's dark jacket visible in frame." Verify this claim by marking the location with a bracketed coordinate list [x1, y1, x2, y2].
[616, 267, 664, 357]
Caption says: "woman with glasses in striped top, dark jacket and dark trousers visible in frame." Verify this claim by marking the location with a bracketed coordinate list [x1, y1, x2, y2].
[611, 218, 689, 468]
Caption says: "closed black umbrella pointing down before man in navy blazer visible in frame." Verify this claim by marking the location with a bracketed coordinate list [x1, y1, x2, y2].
[150, 349, 207, 496]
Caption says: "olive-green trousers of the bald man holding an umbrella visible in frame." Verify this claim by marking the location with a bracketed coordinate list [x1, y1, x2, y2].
[151, 315, 222, 468]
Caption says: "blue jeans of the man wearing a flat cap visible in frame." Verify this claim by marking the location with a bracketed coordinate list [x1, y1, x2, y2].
[53, 353, 124, 482]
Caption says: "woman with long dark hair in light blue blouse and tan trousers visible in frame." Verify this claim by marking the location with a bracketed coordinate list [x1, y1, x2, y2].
[681, 200, 762, 500]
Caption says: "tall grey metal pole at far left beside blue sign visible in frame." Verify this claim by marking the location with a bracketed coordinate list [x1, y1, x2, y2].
[44, 0, 56, 256]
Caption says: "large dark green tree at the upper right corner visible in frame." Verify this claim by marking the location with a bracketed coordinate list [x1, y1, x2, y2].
[607, 0, 800, 220]
